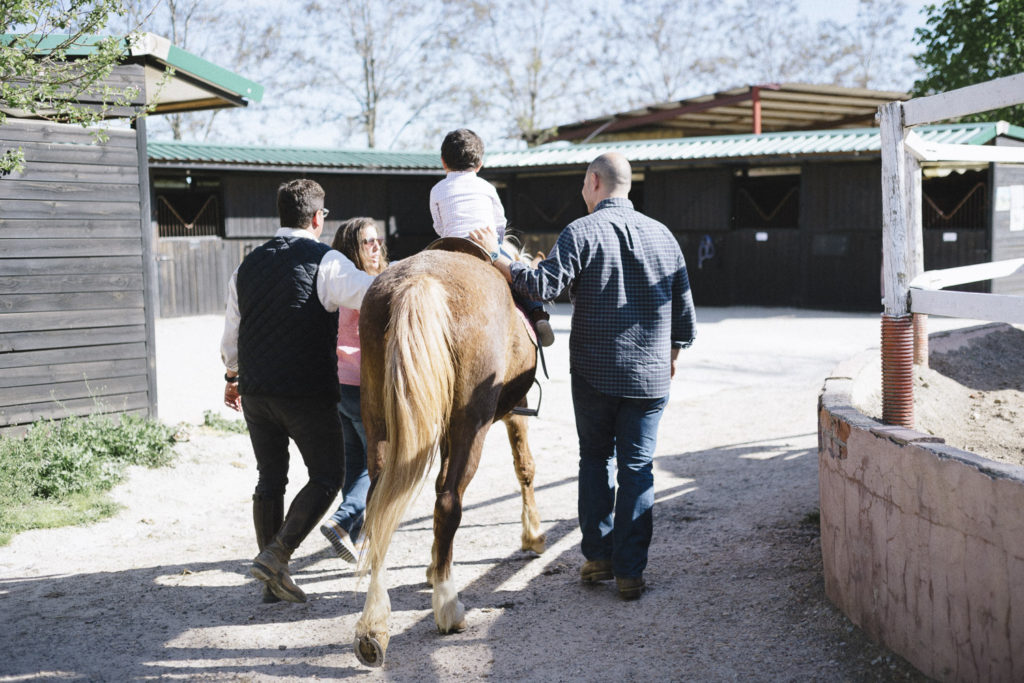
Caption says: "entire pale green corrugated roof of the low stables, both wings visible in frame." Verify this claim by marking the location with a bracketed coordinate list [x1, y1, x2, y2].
[148, 122, 1024, 173]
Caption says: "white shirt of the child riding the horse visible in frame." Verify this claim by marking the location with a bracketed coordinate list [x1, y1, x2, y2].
[430, 171, 505, 243]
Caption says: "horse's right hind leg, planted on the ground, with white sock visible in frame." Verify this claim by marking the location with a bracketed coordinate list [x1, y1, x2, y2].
[427, 425, 487, 633]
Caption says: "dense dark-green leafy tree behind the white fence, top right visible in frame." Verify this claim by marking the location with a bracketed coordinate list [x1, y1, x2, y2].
[913, 0, 1024, 124]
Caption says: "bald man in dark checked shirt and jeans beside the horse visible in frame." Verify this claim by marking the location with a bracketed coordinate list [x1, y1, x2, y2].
[470, 153, 696, 600]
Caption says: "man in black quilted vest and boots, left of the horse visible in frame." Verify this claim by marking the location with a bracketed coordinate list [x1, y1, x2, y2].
[220, 179, 374, 602]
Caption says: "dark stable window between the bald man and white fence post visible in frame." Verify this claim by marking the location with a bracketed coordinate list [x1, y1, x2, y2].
[732, 168, 800, 229]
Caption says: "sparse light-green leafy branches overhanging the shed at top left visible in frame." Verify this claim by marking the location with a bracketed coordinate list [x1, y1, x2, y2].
[0, 0, 142, 173]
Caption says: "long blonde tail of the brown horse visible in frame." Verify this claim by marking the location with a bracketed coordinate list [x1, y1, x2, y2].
[359, 275, 455, 571]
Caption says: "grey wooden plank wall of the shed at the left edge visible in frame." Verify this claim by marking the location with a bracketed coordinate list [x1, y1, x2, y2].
[0, 119, 155, 432]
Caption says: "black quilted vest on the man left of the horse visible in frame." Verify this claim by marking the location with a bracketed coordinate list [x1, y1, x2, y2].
[237, 237, 338, 400]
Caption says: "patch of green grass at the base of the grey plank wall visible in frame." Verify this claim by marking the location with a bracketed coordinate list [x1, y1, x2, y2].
[0, 415, 173, 545]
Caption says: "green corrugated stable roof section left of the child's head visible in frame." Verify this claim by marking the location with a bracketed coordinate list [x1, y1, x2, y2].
[146, 140, 442, 173]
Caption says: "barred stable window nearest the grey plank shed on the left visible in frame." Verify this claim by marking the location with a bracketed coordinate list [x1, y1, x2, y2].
[153, 175, 224, 238]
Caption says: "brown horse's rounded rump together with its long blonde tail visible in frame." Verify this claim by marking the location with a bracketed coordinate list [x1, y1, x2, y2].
[359, 251, 532, 568]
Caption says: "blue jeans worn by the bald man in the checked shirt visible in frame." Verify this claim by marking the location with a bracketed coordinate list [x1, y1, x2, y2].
[572, 374, 669, 578]
